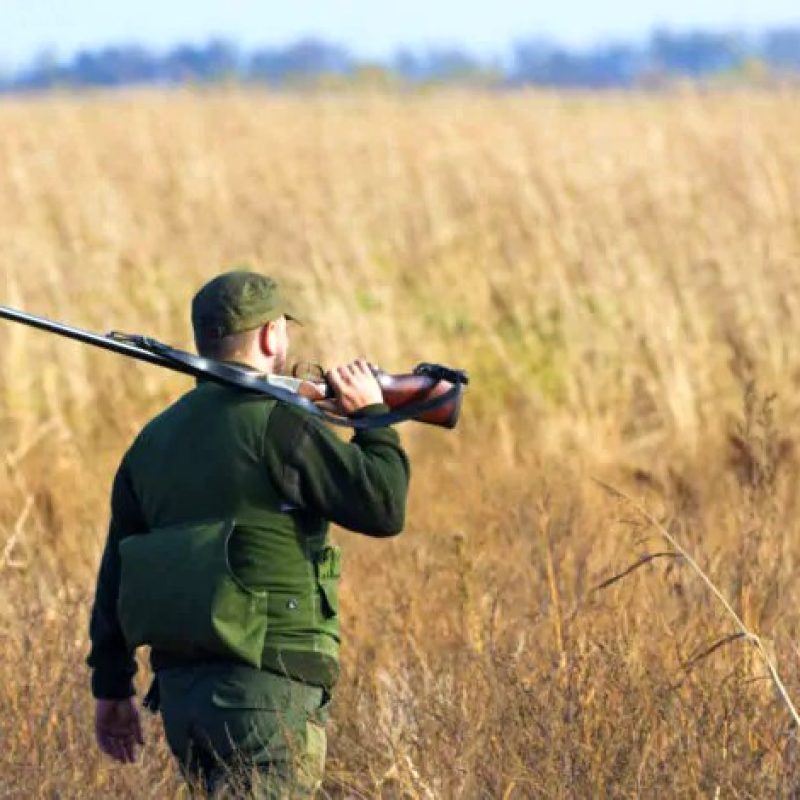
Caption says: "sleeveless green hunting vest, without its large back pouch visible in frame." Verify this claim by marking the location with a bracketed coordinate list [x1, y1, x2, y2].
[120, 382, 340, 685]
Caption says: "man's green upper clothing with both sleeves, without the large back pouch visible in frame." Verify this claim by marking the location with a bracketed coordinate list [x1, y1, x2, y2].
[87, 381, 409, 698]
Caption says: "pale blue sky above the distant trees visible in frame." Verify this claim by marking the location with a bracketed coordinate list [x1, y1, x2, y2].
[0, 0, 800, 67]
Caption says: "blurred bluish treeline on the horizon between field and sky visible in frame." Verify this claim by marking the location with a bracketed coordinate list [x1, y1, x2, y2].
[0, 27, 800, 91]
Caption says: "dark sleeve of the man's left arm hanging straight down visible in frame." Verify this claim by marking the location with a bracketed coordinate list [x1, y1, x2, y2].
[86, 459, 146, 699]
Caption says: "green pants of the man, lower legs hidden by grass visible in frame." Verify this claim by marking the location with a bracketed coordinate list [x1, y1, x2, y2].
[158, 664, 328, 800]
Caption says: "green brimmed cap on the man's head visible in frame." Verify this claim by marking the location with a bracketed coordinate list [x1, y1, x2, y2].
[192, 270, 297, 340]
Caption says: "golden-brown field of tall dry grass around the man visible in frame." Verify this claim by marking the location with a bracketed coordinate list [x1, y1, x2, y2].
[0, 89, 800, 800]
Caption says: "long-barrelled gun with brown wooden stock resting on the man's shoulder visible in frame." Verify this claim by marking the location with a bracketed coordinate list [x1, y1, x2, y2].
[0, 306, 469, 430]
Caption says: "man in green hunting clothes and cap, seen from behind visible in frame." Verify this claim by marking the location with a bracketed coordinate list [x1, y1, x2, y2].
[88, 271, 409, 797]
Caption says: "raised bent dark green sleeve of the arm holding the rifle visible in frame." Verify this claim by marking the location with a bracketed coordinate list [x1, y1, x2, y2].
[264, 404, 410, 536]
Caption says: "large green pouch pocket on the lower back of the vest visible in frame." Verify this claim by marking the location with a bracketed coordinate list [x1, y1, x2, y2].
[117, 520, 267, 668]
